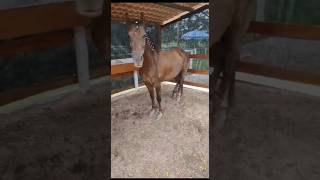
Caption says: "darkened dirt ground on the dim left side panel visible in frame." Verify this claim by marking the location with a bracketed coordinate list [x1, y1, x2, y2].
[0, 83, 110, 180]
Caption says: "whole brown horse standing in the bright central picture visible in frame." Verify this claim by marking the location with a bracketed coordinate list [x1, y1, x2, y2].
[128, 16, 189, 119]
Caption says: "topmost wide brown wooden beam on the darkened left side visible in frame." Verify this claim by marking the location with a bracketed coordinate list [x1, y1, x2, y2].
[0, 2, 90, 40]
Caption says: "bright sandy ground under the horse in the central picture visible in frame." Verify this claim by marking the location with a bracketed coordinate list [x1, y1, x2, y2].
[111, 85, 209, 178]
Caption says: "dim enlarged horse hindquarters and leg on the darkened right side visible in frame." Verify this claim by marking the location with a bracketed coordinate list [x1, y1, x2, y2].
[210, 0, 256, 128]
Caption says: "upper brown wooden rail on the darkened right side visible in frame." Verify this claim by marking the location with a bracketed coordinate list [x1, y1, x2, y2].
[248, 21, 320, 40]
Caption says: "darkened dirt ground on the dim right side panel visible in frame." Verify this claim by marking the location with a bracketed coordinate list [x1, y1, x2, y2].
[210, 82, 320, 180]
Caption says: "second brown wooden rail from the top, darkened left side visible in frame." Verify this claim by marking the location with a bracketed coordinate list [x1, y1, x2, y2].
[0, 30, 73, 56]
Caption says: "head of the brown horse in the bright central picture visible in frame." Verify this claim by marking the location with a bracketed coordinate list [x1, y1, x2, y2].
[128, 14, 146, 67]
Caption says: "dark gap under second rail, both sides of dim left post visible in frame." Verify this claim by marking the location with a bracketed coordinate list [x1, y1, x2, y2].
[0, 41, 105, 92]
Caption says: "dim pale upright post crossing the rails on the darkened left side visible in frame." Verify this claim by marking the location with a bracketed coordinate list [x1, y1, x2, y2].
[74, 26, 90, 90]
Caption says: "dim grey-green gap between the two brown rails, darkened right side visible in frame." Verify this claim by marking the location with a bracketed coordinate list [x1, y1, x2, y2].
[241, 34, 320, 73]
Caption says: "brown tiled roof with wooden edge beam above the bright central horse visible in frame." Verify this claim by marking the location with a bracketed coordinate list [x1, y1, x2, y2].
[111, 3, 209, 26]
